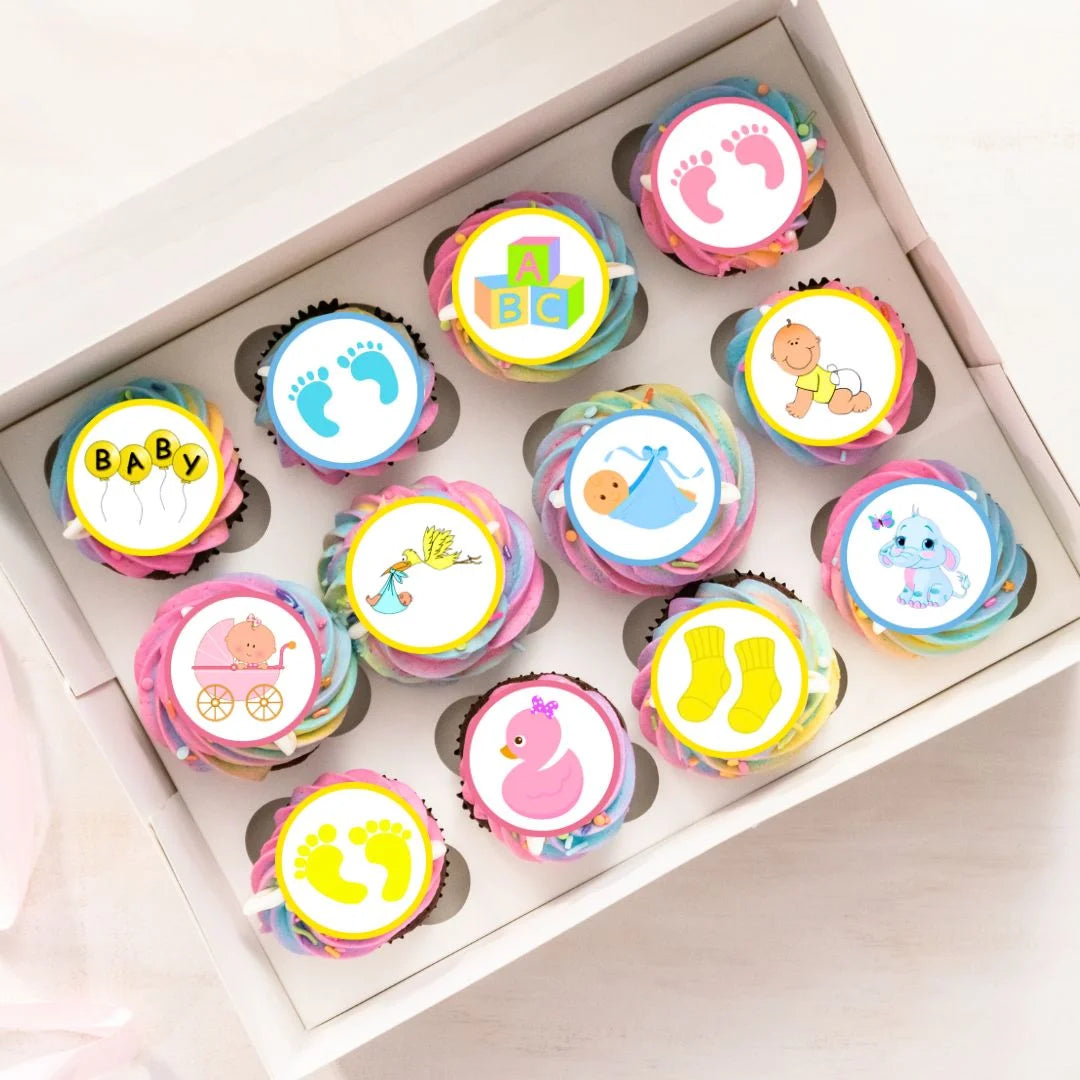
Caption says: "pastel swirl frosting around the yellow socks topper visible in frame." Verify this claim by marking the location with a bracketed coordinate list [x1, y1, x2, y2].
[631, 573, 840, 780]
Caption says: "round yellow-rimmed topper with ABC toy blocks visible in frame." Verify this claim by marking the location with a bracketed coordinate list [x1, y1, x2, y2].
[451, 207, 609, 367]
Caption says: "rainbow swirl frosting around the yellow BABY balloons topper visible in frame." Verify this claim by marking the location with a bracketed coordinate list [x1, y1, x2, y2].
[49, 378, 244, 578]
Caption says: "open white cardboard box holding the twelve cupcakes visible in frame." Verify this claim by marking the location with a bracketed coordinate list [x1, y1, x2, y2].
[0, 0, 1080, 1077]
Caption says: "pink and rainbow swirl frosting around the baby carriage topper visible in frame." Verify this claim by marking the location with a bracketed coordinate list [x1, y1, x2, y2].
[135, 573, 357, 780]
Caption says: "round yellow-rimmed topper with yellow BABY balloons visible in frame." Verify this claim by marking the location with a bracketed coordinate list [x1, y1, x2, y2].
[67, 399, 225, 555]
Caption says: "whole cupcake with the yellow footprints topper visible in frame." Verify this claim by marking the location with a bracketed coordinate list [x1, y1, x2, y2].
[244, 769, 446, 960]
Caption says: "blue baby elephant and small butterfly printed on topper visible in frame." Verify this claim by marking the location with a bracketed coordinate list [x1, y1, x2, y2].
[868, 507, 971, 608]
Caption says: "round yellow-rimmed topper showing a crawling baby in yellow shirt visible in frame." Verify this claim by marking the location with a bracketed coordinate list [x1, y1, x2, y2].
[746, 288, 903, 446]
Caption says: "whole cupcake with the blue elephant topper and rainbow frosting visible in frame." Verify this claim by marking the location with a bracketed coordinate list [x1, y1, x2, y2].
[821, 460, 1027, 656]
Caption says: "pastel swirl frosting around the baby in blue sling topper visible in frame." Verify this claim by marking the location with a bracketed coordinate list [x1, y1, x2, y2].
[532, 383, 757, 596]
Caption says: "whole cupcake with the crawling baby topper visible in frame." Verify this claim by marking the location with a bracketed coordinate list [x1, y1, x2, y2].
[727, 280, 919, 465]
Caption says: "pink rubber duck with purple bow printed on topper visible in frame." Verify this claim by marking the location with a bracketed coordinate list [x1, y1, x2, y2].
[501, 694, 585, 821]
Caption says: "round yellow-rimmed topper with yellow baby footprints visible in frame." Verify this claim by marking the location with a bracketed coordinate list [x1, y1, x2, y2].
[274, 782, 433, 940]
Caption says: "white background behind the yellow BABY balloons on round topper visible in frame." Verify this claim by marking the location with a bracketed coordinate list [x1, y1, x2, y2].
[69, 401, 222, 554]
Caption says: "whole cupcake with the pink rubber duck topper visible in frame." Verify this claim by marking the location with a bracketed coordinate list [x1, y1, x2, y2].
[458, 674, 634, 862]
